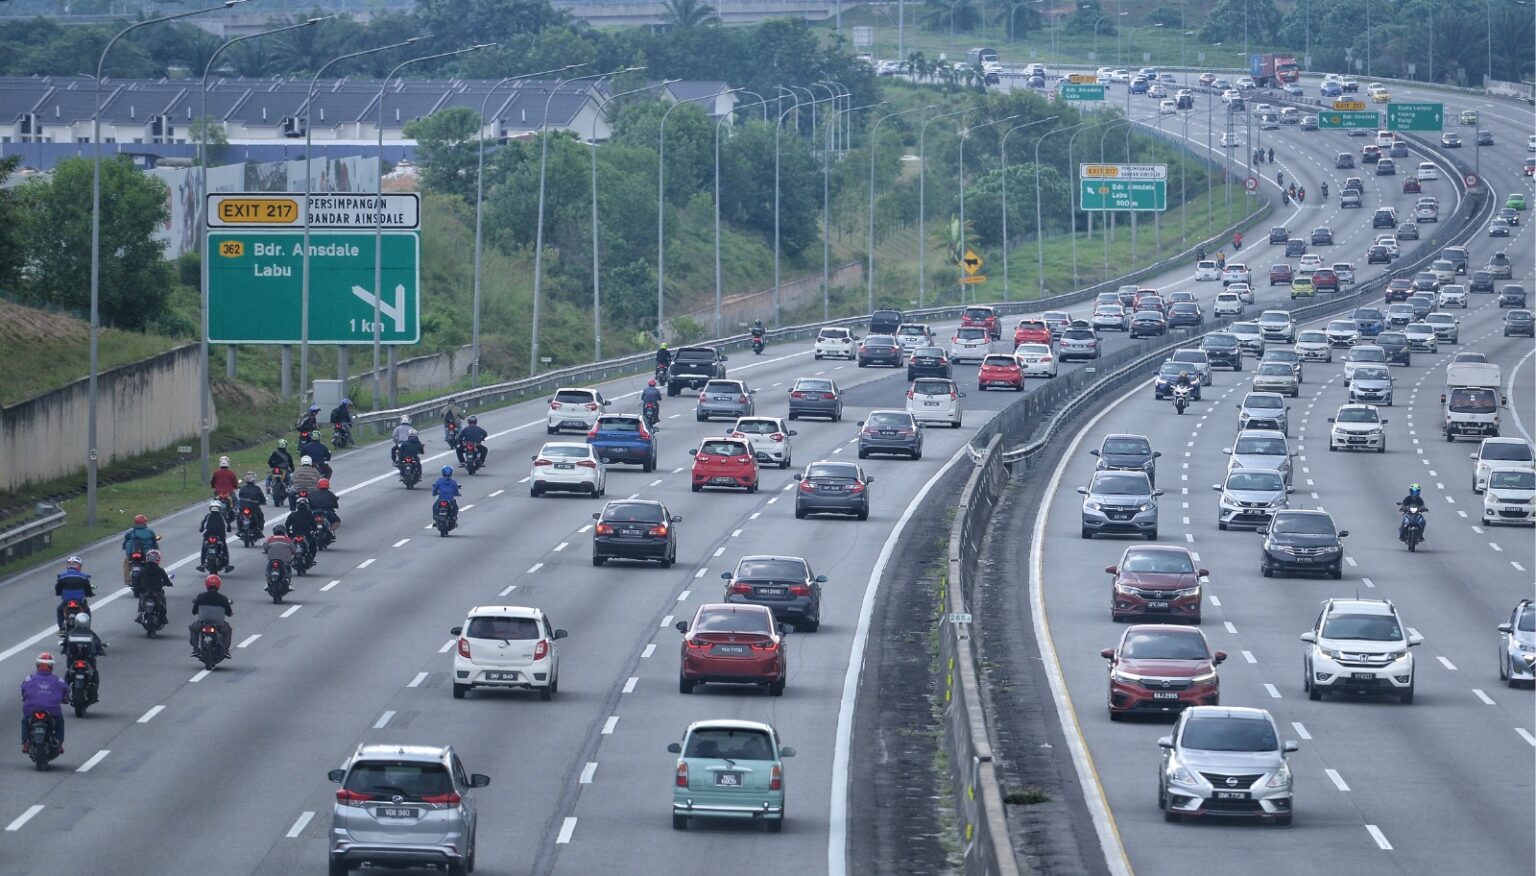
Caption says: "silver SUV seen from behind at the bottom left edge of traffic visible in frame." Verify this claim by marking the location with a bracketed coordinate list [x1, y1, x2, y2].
[329, 745, 490, 876]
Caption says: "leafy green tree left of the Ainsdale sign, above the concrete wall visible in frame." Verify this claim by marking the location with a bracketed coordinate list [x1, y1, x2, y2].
[17, 157, 174, 329]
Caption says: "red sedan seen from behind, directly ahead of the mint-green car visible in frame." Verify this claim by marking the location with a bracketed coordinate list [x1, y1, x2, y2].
[677, 602, 790, 696]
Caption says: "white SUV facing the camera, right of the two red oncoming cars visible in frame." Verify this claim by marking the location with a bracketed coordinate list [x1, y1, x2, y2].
[1301, 599, 1424, 704]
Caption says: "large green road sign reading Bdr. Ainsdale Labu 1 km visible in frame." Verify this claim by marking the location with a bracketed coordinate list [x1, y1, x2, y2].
[203, 231, 421, 344]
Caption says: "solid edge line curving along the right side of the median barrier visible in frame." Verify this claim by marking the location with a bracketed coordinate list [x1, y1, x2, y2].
[1029, 380, 1150, 876]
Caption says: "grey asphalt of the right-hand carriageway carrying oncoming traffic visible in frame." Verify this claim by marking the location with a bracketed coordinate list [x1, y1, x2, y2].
[995, 80, 1536, 876]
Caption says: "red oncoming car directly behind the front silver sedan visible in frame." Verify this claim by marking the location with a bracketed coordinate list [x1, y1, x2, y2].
[1098, 624, 1227, 721]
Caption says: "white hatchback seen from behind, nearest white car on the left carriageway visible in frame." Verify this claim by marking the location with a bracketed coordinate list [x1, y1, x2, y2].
[449, 606, 567, 699]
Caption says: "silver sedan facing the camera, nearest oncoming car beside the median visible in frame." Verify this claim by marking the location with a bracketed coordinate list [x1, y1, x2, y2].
[1157, 705, 1296, 827]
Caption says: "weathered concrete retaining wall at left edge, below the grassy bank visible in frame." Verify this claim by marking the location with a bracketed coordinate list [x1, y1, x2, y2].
[0, 344, 208, 490]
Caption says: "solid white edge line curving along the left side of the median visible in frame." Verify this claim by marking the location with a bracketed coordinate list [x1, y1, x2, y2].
[829, 441, 971, 876]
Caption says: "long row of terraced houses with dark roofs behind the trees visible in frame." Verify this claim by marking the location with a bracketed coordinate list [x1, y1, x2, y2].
[0, 77, 736, 146]
